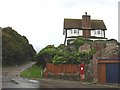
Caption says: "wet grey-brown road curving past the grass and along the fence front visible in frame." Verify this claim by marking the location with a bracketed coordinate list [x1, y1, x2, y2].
[2, 62, 118, 89]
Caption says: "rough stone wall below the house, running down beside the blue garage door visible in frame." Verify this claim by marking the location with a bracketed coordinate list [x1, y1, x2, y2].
[79, 40, 120, 83]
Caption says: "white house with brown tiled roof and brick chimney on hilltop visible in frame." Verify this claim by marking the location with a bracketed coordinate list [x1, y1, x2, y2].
[63, 12, 107, 45]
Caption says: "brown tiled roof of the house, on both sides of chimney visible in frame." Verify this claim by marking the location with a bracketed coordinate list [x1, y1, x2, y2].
[64, 19, 107, 30]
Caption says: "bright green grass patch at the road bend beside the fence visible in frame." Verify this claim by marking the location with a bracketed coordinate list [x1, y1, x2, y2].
[20, 65, 43, 79]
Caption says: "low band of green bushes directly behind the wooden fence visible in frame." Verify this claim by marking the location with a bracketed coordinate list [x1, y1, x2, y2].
[36, 46, 94, 68]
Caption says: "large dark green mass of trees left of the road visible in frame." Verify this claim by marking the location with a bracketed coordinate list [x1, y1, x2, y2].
[2, 27, 36, 66]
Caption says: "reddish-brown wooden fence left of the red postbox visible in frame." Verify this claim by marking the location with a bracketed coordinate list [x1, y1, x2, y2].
[44, 63, 80, 78]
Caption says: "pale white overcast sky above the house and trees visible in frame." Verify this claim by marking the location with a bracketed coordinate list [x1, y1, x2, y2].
[0, 0, 119, 51]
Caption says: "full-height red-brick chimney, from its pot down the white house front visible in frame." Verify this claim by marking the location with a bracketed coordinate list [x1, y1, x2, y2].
[82, 12, 91, 38]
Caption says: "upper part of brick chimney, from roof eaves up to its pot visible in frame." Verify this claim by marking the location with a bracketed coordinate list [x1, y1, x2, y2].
[82, 12, 91, 29]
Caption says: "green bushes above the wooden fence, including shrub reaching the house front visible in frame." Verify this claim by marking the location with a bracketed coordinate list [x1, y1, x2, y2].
[35, 38, 95, 68]
